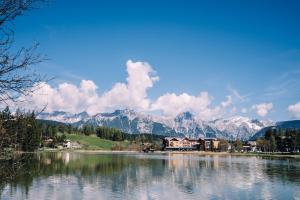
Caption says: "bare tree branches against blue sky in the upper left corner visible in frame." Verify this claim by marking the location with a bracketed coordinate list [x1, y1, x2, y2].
[0, 0, 45, 102]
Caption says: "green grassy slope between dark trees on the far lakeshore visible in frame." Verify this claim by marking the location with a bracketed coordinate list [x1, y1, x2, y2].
[66, 134, 118, 150]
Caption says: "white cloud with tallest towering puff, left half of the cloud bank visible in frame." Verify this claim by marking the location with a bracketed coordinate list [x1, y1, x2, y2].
[11, 60, 159, 114]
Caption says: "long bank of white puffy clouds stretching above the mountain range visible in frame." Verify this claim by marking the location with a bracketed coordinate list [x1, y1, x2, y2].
[9, 60, 236, 120]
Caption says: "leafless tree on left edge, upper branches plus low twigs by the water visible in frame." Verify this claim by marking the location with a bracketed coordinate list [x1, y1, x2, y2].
[0, 0, 46, 187]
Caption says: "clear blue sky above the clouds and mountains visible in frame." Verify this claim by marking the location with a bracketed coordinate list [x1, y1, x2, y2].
[14, 0, 300, 121]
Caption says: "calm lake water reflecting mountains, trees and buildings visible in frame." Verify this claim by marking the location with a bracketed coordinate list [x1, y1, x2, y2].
[0, 152, 300, 200]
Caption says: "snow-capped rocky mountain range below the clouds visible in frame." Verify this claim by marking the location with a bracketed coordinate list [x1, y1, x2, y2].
[38, 109, 272, 140]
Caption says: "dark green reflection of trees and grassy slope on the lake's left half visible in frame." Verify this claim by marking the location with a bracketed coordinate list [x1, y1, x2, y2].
[0, 152, 169, 196]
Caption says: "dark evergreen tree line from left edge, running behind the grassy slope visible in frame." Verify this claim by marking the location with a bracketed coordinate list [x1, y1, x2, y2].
[0, 107, 163, 155]
